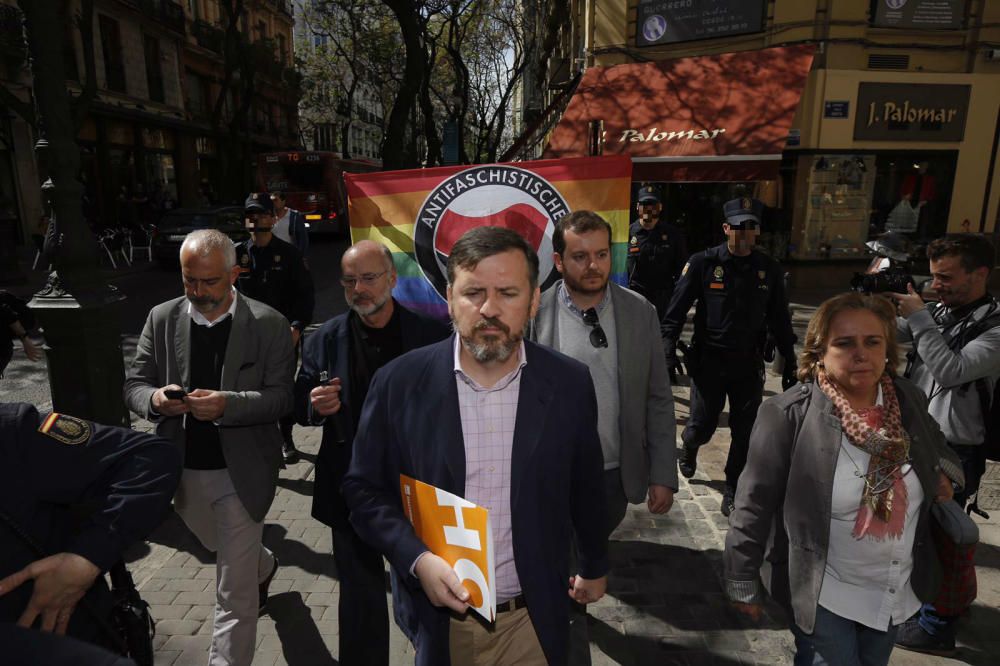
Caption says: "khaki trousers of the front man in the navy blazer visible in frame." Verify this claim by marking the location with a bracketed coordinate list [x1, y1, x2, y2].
[448, 608, 548, 666]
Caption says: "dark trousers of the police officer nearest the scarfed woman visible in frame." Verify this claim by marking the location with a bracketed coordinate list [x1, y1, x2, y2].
[681, 352, 764, 490]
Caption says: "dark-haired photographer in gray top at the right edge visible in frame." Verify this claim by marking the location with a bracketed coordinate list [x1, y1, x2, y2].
[887, 234, 1000, 654]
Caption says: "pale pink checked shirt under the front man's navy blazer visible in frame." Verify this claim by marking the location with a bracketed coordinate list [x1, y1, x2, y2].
[455, 335, 527, 603]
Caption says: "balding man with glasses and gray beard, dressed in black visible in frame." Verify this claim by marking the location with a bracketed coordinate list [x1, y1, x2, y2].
[295, 240, 449, 666]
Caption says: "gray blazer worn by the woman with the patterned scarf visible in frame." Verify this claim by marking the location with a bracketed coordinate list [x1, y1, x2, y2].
[723, 378, 964, 633]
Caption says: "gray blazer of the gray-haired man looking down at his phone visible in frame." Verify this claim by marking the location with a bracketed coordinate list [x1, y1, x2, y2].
[125, 294, 295, 521]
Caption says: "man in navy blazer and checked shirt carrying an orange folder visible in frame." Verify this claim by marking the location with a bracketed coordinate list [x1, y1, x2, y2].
[342, 227, 608, 666]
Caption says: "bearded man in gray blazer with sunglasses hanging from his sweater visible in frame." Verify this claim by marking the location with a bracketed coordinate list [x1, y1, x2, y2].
[533, 211, 677, 535]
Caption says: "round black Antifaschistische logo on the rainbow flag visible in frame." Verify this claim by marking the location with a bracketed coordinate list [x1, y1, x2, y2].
[413, 164, 569, 298]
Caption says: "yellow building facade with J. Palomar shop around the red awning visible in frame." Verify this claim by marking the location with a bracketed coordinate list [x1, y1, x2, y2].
[520, 0, 1000, 272]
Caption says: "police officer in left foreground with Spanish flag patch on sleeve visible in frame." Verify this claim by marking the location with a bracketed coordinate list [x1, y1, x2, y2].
[0, 403, 181, 663]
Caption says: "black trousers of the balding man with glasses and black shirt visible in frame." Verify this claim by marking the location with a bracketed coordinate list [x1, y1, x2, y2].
[333, 526, 389, 666]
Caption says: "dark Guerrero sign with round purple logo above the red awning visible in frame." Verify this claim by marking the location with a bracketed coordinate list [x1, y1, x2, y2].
[635, 0, 767, 46]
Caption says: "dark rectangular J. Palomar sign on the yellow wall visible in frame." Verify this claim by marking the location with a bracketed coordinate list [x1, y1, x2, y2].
[854, 83, 971, 141]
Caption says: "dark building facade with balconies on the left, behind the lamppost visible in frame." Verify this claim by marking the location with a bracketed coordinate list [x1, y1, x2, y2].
[0, 0, 301, 243]
